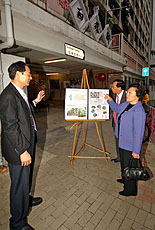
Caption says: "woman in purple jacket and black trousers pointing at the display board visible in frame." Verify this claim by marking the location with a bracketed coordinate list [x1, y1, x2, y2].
[105, 83, 146, 196]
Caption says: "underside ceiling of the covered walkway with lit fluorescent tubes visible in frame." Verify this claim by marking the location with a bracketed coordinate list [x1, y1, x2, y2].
[3, 46, 116, 74]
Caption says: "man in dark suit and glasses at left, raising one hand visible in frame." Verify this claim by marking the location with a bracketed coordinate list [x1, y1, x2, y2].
[0, 61, 45, 230]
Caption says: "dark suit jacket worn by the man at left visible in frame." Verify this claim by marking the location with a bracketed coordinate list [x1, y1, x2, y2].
[0, 83, 35, 165]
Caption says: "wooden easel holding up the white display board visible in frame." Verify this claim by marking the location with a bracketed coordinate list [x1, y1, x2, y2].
[68, 69, 111, 165]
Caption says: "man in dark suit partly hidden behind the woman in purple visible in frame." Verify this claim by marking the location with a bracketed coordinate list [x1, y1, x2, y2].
[111, 79, 126, 163]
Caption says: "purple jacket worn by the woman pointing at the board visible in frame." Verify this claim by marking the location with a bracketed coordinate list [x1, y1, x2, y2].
[107, 100, 146, 154]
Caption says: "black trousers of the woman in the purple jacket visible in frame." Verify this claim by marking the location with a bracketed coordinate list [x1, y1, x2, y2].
[119, 148, 138, 195]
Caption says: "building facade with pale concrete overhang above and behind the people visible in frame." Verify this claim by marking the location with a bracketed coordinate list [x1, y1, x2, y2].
[0, 0, 155, 100]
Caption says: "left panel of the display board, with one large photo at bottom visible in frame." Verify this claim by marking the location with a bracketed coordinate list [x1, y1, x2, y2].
[65, 88, 88, 120]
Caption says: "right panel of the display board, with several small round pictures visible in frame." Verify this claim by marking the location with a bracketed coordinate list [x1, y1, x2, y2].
[88, 89, 109, 120]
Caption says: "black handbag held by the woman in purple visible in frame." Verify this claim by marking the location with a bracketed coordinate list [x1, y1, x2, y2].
[122, 157, 150, 180]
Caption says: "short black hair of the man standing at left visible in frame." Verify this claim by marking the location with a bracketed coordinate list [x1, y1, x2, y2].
[8, 61, 27, 80]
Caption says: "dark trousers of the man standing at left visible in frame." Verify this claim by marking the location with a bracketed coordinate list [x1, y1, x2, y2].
[8, 163, 30, 230]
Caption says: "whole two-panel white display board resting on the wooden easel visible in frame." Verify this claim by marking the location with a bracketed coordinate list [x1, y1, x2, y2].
[65, 88, 109, 120]
